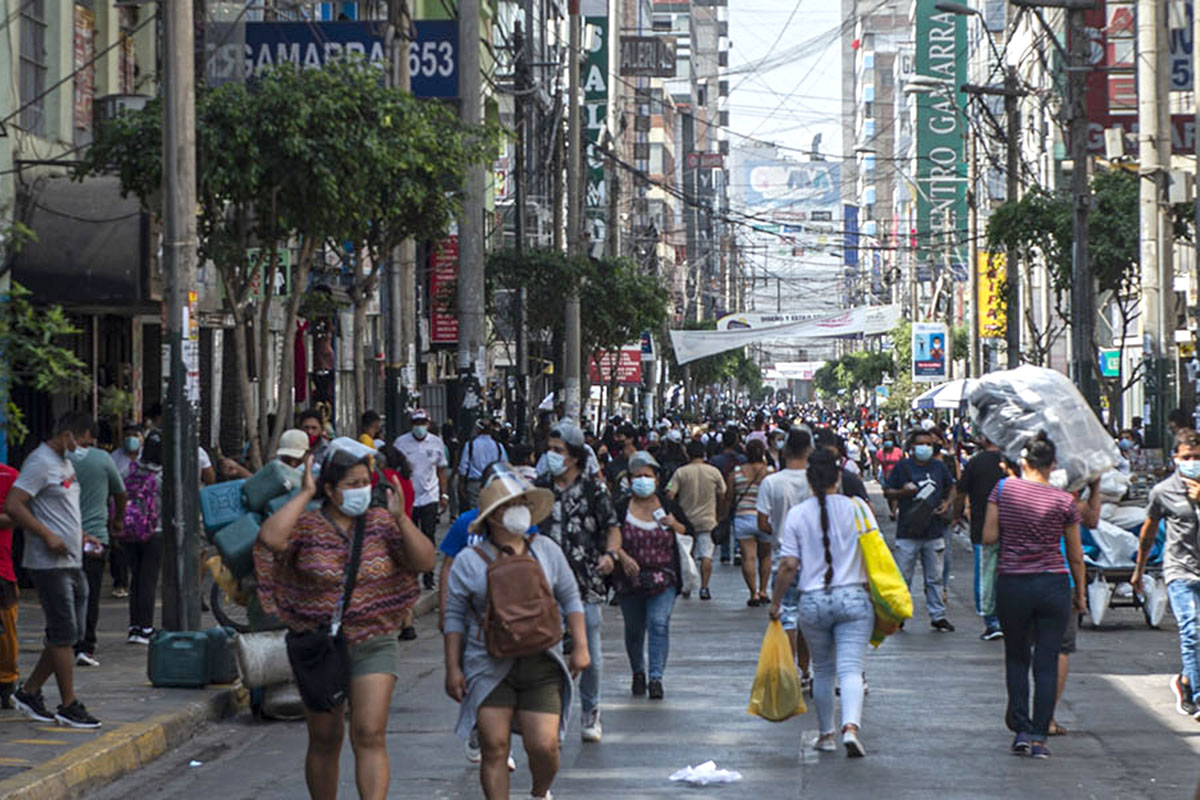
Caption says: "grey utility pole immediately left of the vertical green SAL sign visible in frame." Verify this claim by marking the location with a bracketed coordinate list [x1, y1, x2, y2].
[563, 0, 583, 425]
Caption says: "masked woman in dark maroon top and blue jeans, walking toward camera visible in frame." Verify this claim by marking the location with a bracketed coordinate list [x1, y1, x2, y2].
[613, 451, 686, 700]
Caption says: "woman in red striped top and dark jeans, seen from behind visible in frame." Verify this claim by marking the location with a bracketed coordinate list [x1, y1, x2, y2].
[983, 431, 1086, 758]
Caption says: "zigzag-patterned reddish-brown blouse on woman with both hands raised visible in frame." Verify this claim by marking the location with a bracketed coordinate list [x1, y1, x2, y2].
[254, 509, 420, 644]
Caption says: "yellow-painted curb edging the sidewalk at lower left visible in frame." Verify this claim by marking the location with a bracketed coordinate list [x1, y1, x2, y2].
[0, 591, 438, 800]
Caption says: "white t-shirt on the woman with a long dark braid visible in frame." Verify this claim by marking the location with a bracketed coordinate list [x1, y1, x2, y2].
[780, 494, 875, 591]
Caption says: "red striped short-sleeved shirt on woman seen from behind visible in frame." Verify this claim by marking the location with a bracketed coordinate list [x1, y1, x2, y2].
[988, 477, 1079, 575]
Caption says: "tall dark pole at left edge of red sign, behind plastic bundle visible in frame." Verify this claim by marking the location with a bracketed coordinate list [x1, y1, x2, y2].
[1067, 8, 1100, 414]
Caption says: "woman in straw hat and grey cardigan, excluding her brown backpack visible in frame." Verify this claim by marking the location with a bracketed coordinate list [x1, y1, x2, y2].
[445, 463, 590, 800]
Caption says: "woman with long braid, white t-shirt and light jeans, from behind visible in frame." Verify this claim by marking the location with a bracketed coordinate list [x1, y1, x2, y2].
[770, 450, 875, 757]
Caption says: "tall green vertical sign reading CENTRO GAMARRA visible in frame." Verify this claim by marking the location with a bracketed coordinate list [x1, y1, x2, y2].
[916, 0, 967, 275]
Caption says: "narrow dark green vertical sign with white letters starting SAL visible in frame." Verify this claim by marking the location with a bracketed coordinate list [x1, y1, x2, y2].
[581, 0, 608, 255]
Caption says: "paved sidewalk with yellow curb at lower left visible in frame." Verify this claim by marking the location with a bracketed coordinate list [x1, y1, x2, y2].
[0, 556, 437, 800]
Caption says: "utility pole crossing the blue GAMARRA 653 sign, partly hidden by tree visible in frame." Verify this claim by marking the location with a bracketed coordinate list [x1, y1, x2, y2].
[384, 0, 416, 441]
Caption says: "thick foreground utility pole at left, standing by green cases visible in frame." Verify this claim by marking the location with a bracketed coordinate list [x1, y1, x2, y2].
[158, 0, 200, 631]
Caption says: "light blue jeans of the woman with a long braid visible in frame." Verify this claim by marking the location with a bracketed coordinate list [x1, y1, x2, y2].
[800, 585, 875, 734]
